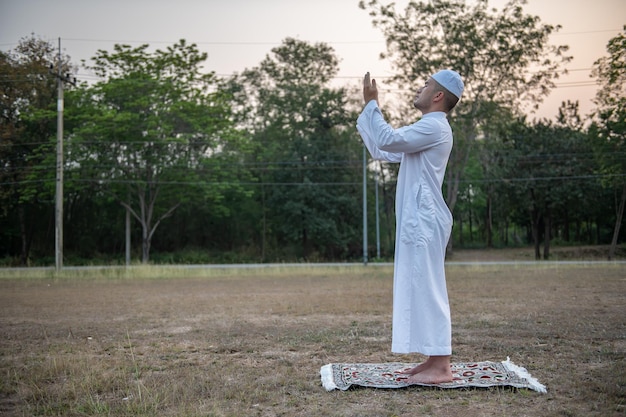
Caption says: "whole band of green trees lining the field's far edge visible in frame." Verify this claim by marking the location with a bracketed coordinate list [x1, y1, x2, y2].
[0, 22, 626, 266]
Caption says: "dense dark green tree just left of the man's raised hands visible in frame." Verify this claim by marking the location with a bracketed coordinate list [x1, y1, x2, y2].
[228, 38, 361, 259]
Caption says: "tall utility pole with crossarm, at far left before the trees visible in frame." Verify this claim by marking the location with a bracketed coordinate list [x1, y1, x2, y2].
[50, 38, 76, 272]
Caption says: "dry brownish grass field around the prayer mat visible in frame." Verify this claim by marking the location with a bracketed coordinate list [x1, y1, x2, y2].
[0, 264, 626, 417]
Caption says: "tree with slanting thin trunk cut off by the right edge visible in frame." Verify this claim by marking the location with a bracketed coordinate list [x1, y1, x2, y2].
[590, 26, 626, 259]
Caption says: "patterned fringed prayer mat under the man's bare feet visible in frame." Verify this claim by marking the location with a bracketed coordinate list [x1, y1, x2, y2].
[320, 358, 546, 393]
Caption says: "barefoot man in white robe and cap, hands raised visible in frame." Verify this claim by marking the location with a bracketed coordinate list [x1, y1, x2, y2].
[357, 70, 464, 384]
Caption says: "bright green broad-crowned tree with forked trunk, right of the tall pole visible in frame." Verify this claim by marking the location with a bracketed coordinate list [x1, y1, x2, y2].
[69, 40, 238, 263]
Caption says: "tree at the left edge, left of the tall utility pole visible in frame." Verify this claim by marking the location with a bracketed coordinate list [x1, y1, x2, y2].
[0, 35, 71, 265]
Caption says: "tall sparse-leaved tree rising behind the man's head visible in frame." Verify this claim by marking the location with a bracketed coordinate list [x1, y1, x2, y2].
[359, 0, 571, 224]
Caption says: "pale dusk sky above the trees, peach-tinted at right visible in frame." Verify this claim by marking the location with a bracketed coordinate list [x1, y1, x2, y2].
[0, 0, 626, 119]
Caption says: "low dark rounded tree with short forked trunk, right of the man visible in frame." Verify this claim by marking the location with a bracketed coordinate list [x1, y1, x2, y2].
[496, 112, 597, 259]
